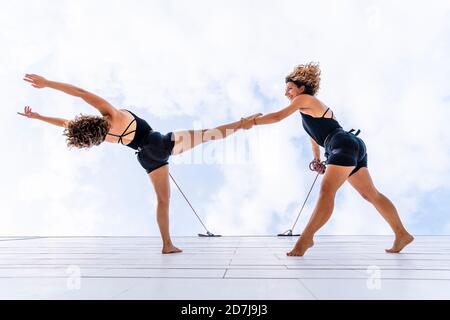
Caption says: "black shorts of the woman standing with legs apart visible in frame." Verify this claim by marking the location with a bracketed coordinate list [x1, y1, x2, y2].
[325, 130, 367, 176]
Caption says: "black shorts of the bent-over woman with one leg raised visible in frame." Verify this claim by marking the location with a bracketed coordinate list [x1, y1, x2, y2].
[136, 131, 175, 173]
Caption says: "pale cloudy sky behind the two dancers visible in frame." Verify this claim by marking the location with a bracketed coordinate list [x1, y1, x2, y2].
[0, 0, 450, 235]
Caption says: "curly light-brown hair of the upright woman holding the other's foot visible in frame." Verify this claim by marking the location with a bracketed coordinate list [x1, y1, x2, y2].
[286, 62, 320, 96]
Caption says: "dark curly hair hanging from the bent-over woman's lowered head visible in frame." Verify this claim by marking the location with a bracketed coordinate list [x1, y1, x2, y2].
[64, 114, 111, 149]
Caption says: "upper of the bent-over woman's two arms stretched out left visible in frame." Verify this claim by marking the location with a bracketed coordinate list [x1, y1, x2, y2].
[24, 74, 118, 118]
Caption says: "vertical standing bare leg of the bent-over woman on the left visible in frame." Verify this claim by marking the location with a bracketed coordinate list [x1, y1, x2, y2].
[149, 165, 182, 254]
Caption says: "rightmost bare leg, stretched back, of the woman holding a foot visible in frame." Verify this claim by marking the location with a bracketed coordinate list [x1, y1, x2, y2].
[348, 168, 414, 253]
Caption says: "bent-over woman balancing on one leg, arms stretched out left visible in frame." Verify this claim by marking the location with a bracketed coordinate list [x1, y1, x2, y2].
[18, 74, 261, 254]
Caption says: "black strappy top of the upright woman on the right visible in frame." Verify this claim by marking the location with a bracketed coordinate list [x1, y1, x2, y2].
[300, 108, 342, 147]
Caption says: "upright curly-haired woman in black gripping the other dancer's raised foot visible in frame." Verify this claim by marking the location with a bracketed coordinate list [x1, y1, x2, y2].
[248, 63, 414, 256]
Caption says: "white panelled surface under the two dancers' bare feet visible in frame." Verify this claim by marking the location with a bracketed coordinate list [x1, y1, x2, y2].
[0, 236, 450, 300]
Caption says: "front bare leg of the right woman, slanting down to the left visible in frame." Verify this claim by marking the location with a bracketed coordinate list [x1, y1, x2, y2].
[287, 165, 355, 256]
